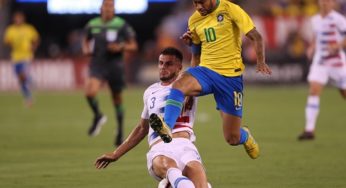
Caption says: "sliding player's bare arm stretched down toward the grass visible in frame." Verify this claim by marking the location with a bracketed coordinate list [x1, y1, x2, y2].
[95, 119, 149, 169]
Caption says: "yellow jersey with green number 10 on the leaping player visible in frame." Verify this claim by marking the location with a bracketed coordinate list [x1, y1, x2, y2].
[189, 0, 255, 77]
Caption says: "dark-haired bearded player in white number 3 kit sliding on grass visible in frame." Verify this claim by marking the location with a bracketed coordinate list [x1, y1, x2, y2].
[95, 47, 208, 188]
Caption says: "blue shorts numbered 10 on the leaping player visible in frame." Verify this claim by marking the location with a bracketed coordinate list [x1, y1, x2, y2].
[186, 66, 243, 117]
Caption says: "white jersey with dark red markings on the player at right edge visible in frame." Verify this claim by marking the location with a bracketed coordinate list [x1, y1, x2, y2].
[311, 11, 346, 67]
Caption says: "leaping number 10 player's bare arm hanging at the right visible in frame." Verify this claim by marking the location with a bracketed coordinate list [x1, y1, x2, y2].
[246, 28, 272, 74]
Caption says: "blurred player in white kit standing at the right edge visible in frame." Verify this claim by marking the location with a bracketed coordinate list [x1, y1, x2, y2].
[298, 0, 346, 140]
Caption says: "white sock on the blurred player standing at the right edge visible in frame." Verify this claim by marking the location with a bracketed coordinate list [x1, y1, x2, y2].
[305, 96, 320, 132]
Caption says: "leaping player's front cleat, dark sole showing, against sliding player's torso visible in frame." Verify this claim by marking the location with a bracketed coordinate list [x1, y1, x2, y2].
[149, 114, 172, 143]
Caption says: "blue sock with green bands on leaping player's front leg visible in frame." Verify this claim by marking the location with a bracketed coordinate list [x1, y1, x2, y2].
[164, 88, 185, 129]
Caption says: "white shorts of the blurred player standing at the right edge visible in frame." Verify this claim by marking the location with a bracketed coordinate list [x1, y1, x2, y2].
[308, 63, 346, 89]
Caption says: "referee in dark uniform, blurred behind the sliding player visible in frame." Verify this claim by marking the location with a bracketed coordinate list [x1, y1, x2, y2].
[83, 0, 138, 146]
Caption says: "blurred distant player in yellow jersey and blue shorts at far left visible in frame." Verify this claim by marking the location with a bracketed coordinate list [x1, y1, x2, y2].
[4, 11, 40, 107]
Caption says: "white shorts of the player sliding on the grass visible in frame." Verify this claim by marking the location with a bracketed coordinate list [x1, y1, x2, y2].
[147, 138, 202, 181]
